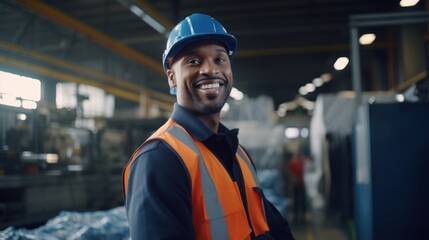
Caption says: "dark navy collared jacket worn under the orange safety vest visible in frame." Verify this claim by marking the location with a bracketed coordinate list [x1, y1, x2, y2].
[125, 104, 293, 240]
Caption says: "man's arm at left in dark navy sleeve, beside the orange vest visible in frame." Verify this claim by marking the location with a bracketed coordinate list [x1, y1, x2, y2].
[125, 141, 195, 240]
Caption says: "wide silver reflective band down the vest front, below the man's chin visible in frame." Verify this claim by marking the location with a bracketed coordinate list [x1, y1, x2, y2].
[167, 126, 229, 240]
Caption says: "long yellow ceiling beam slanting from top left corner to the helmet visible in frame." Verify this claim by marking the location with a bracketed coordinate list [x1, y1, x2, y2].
[15, 0, 164, 75]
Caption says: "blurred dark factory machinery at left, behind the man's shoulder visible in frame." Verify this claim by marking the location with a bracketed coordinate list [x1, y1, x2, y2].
[0, 105, 165, 229]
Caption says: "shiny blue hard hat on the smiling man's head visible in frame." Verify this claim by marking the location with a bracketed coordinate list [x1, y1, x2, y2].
[162, 13, 237, 70]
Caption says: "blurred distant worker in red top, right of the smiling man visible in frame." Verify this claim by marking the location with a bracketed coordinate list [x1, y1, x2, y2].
[287, 148, 308, 224]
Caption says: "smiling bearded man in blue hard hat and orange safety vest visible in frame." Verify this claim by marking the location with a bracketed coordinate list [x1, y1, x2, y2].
[123, 14, 293, 240]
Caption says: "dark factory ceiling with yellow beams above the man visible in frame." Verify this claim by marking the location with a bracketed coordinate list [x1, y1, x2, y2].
[0, 0, 425, 110]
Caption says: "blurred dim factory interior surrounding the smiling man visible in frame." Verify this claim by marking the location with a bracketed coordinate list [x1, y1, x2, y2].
[0, 0, 429, 240]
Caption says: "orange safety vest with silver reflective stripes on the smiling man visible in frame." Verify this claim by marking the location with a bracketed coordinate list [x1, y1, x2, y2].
[123, 119, 269, 240]
